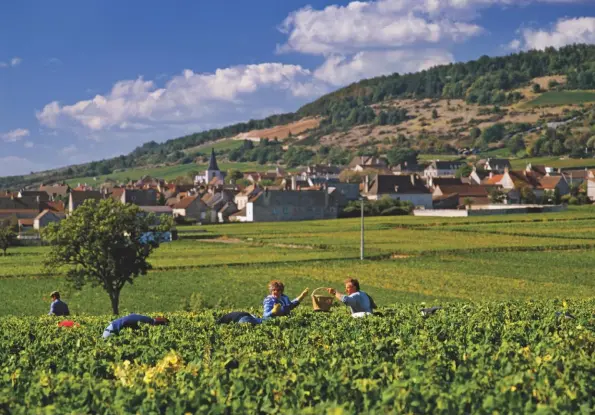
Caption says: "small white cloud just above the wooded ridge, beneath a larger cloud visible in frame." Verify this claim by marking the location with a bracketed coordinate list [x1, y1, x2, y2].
[314, 50, 454, 86]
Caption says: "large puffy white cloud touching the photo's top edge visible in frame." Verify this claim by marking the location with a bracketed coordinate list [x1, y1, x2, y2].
[279, 0, 482, 54]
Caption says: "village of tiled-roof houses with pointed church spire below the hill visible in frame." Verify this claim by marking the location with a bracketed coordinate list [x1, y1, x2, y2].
[0, 152, 595, 232]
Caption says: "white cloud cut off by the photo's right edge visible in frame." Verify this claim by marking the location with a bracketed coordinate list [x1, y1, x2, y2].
[519, 17, 595, 49]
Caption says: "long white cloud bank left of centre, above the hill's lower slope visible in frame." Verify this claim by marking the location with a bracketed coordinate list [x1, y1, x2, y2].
[37, 63, 311, 132]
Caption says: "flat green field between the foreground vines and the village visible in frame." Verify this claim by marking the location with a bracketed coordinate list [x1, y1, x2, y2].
[0, 206, 595, 315]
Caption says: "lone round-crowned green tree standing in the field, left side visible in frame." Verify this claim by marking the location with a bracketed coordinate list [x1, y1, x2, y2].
[42, 198, 172, 314]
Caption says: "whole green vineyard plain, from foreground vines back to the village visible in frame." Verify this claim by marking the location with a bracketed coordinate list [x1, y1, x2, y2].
[0, 207, 595, 414]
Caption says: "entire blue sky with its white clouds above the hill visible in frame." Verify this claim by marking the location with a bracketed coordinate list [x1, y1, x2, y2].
[0, 0, 595, 176]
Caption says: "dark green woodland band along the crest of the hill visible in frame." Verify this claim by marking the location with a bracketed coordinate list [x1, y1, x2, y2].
[0, 45, 595, 188]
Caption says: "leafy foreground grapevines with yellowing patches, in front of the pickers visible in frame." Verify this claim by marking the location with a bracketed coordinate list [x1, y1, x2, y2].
[0, 300, 595, 414]
